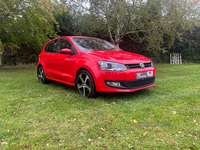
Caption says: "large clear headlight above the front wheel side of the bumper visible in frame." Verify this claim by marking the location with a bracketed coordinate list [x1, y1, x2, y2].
[98, 61, 127, 71]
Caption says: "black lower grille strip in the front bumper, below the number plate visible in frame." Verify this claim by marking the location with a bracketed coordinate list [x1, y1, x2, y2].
[105, 77, 155, 89]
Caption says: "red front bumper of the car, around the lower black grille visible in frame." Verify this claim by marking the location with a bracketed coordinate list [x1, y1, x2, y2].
[94, 67, 156, 92]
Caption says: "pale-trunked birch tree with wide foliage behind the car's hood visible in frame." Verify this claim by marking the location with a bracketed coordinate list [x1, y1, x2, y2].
[67, 0, 199, 51]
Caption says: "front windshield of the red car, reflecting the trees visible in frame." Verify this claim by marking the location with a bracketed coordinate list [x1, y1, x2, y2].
[72, 38, 119, 51]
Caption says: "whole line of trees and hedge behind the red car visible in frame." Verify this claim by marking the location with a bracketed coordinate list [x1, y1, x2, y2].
[0, 0, 200, 64]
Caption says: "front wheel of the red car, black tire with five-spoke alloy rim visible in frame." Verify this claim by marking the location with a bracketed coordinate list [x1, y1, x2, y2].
[75, 70, 97, 98]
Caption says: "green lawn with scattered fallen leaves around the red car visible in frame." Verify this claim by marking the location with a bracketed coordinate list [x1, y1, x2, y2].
[0, 64, 200, 150]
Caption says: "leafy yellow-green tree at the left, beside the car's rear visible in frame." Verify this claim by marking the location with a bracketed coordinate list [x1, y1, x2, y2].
[0, 0, 64, 51]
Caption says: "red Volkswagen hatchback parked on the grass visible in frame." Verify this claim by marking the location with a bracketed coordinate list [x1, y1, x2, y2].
[37, 36, 156, 97]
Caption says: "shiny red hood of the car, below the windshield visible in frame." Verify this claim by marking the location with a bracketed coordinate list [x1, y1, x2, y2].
[84, 51, 151, 64]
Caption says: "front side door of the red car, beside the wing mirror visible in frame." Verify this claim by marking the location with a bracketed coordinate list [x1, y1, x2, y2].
[56, 38, 77, 85]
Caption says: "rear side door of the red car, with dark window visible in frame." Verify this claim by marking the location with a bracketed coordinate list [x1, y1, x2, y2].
[42, 39, 58, 78]
